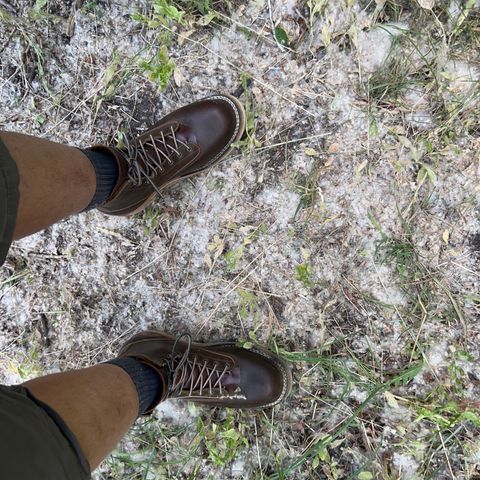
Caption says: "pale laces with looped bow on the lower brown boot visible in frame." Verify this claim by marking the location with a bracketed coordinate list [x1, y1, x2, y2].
[167, 333, 230, 397]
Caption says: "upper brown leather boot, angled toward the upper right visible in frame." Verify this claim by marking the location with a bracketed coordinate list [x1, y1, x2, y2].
[91, 95, 245, 215]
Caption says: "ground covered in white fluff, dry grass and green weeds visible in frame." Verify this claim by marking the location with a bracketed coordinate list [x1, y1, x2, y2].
[0, 0, 480, 480]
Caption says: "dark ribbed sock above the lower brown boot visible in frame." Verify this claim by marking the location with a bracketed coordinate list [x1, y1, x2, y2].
[105, 358, 162, 416]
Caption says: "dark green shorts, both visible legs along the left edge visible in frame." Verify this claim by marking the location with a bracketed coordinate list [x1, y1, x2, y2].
[0, 140, 90, 480]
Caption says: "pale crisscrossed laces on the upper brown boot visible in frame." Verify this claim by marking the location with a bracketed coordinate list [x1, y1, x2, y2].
[120, 126, 191, 194]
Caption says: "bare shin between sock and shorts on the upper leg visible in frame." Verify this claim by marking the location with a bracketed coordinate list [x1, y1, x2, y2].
[0, 132, 96, 239]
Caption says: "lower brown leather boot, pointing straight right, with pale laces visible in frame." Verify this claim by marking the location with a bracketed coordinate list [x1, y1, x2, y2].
[119, 331, 292, 414]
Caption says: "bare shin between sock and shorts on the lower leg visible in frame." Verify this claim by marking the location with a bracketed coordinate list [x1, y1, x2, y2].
[24, 365, 138, 470]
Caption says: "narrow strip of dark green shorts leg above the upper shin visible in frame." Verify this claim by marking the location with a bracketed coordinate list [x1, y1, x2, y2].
[0, 140, 19, 265]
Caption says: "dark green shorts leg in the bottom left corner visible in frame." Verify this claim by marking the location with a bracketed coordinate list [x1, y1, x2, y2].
[0, 385, 90, 480]
